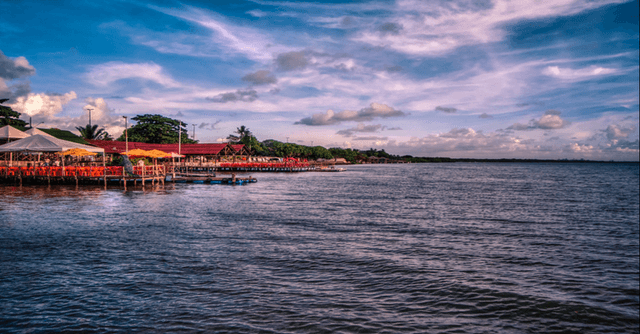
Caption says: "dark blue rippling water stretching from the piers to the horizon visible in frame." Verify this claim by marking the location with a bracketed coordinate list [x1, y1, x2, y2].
[0, 163, 640, 333]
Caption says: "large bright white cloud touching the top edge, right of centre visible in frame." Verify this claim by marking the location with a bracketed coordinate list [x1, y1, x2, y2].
[355, 0, 624, 56]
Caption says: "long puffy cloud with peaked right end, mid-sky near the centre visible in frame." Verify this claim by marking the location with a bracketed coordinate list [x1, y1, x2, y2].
[294, 102, 407, 126]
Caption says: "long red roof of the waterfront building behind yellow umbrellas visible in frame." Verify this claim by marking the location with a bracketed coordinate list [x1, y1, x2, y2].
[87, 140, 244, 155]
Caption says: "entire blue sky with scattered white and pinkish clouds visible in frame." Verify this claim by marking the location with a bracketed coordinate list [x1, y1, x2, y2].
[0, 0, 639, 161]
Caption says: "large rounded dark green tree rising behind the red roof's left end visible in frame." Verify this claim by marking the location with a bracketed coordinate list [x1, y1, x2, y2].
[117, 114, 197, 144]
